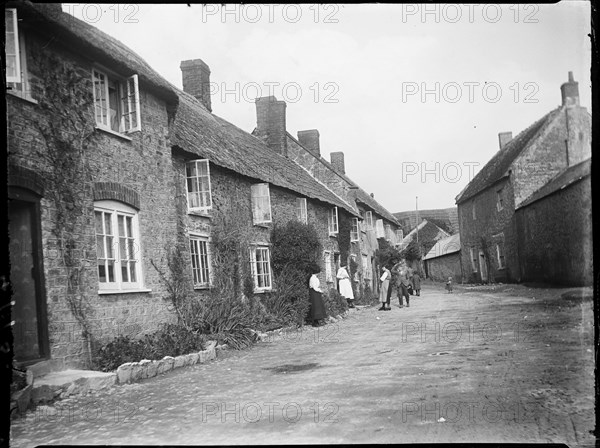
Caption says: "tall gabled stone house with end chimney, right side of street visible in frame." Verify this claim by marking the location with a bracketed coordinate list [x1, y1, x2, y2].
[456, 72, 591, 282]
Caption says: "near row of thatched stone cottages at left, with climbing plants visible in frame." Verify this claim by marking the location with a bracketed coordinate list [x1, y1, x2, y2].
[5, 1, 360, 371]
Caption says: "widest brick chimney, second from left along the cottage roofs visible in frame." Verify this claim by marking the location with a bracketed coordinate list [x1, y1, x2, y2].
[256, 96, 287, 157]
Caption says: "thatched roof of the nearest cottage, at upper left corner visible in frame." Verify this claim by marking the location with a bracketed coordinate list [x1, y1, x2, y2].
[14, 1, 177, 105]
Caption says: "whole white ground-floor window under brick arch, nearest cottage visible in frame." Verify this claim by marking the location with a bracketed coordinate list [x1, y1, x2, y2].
[94, 201, 142, 291]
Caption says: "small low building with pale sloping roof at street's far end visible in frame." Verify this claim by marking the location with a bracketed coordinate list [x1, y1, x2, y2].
[423, 233, 462, 283]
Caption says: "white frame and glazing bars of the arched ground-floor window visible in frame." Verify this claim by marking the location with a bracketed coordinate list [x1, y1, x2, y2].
[94, 200, 143, 292]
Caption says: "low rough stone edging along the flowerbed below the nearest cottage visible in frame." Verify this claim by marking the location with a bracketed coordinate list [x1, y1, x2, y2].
[117, 341, 217, 384]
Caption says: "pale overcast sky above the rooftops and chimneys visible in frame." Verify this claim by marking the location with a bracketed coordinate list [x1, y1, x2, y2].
[63, 0, 591, 212]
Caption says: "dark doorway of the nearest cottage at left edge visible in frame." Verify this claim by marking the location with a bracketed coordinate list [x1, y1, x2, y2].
[8, 188, 49, 364]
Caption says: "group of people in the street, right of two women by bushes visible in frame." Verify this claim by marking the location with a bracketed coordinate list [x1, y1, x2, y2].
[379, 260, 421, 311]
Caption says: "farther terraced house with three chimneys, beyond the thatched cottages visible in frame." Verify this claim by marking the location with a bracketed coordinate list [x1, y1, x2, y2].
[253, 96, 400, 294]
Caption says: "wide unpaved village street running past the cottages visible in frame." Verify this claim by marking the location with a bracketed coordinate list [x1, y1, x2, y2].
[11, 283, 594, 447]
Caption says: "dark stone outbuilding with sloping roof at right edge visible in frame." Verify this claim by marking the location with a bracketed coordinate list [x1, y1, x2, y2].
[515, 159, 594, 286]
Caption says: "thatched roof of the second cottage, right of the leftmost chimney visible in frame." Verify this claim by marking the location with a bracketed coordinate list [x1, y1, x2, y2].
[170, 90, 359, 216]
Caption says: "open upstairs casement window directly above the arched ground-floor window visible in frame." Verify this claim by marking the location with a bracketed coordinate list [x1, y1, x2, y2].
[92, 69, 141, 133]
